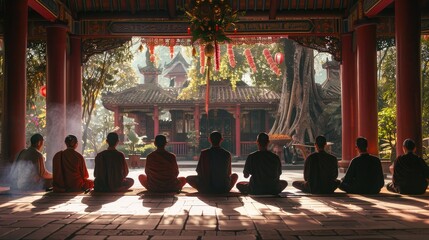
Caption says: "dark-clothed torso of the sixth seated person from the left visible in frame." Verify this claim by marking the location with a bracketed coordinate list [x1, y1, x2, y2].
[244, 150, 282, 194]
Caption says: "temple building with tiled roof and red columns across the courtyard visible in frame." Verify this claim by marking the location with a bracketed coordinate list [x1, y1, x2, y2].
[102, 52, 280, 157]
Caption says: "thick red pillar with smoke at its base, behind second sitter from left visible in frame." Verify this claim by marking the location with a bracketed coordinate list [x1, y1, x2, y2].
[46, 24, 67, 169]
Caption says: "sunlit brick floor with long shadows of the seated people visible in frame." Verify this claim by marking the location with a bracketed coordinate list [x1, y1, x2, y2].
[0, 170, 429, 240]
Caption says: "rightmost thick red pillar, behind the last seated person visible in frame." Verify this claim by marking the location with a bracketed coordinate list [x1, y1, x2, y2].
[395, 0, 422, 156]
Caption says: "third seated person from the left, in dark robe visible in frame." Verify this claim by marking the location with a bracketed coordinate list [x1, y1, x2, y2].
[94, 132, 134, 192]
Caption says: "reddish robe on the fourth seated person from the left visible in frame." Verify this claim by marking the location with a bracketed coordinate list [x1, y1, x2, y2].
[145, 149, 181, 192]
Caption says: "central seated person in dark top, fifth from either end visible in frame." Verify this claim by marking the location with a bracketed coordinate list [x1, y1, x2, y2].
[186, 131, 238, 193]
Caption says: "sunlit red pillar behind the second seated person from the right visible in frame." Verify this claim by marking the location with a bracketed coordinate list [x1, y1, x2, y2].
[355, 23, 378, 155]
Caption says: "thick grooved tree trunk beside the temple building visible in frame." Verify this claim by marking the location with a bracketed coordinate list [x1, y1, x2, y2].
[270, 40, 324, 143]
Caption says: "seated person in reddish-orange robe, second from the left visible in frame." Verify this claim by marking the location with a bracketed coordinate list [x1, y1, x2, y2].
[52, 135, 94, 192]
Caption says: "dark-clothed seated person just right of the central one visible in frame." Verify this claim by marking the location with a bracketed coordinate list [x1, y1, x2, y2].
[237, 133, 287, 195]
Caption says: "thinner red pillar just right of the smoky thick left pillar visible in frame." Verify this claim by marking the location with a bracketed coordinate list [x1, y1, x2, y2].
[66, 36, 82, 150]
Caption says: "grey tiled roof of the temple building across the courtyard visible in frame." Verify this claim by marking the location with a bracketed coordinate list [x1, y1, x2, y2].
[102, 84, 280, 108]
